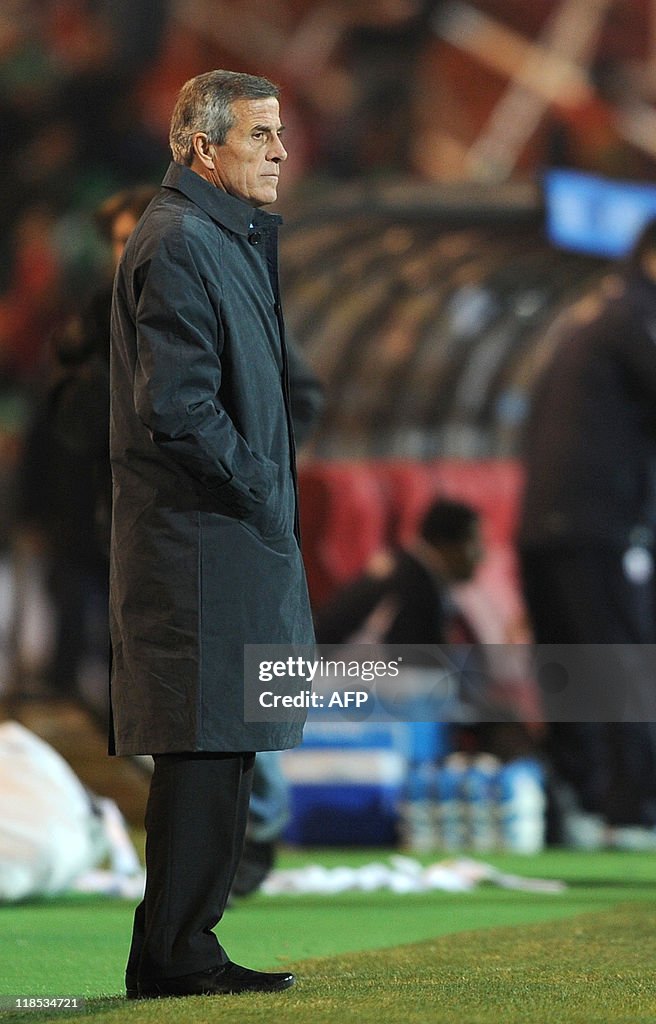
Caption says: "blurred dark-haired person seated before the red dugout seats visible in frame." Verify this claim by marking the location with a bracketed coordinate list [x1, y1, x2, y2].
[315, 498, 534, 760]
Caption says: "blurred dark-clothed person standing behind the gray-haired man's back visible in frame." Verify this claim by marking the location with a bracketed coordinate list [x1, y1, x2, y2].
[16, 185, 157, 716]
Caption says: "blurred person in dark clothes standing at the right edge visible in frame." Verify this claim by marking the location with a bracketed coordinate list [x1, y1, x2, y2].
[519, 221, 656, 846]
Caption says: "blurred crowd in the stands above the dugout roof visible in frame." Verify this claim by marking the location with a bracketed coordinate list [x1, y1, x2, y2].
[0, 0, 656, 383]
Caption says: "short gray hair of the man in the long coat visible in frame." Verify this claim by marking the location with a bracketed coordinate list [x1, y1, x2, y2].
[169, 71, 280, 167]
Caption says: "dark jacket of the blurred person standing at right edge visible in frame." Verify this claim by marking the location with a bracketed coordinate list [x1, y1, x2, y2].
[519, 270, 656, 547]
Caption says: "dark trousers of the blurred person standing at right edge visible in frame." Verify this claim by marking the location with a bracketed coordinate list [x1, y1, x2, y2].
[521, 544, 656, 825]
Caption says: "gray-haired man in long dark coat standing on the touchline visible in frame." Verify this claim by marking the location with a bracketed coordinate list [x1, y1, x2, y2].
[111, 72, 313, 997]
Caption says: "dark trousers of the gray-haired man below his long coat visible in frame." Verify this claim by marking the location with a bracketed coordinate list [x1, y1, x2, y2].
[126, 754, 255, 984]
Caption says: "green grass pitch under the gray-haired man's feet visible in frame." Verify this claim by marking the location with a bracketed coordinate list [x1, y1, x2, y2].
[0, 850, 656, 1024]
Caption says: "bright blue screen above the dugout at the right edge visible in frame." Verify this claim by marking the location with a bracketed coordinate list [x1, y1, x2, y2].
[543, 170, 656, 259]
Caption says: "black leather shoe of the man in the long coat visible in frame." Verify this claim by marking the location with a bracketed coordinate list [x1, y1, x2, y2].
[137, 961, 296, 999]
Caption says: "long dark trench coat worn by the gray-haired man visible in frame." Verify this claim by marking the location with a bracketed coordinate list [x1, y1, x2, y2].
[111, 164, 313, 754]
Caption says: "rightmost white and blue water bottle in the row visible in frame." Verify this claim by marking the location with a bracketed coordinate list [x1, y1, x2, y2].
[498, 758, 546, 853]
